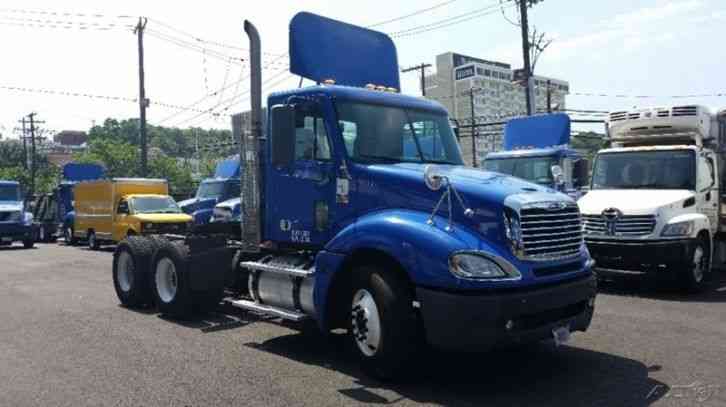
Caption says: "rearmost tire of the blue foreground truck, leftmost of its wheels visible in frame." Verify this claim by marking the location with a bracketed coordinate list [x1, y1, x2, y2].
[112, 236, 158, 308]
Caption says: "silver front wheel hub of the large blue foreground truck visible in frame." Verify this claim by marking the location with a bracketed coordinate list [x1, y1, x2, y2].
[351, 289, 381, 356]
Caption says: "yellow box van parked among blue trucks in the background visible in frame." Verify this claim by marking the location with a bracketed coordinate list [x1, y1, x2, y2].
[72, 178, 192, 250]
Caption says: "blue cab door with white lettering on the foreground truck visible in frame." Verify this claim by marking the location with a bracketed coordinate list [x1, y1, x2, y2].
[265, 99, 336, 247]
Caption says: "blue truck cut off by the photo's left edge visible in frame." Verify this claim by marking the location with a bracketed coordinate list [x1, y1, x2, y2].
[0, 180, 35, 249]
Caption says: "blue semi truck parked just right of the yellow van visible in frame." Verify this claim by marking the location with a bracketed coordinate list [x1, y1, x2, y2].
[179, 157, 240, 225]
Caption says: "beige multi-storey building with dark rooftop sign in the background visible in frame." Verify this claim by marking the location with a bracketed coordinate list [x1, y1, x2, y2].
[426, 52, 570, 164]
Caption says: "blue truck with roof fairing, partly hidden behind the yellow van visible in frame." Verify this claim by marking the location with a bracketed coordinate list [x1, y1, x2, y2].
[33, 163, 104, 244]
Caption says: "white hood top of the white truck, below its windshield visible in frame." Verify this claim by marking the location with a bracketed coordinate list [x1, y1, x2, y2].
[577, 189, 694, 215]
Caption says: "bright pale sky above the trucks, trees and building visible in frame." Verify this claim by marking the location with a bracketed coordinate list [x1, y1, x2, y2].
[0, 0, 726, 135]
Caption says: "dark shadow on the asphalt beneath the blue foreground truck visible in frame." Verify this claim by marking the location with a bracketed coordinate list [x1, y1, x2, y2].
[245, 330, 669, 406]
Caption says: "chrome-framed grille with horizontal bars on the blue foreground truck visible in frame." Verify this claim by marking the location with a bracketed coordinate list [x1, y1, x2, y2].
[519, 204, 582, 260]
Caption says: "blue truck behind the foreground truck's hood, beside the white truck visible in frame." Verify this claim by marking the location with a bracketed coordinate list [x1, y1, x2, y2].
[484, 113, 590, 199]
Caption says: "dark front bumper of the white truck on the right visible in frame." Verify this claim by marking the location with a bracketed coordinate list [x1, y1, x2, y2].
[586, 238, 696, 277]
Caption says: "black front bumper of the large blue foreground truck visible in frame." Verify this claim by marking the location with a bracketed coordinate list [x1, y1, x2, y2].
[416, 274, 597, 351]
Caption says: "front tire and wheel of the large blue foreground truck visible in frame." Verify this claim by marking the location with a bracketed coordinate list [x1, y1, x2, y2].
[348, 266, 421, 380]
